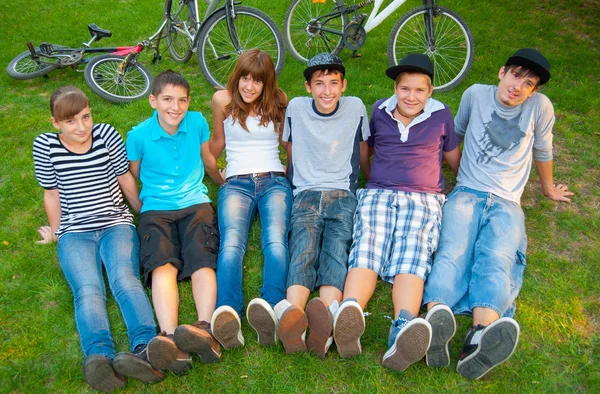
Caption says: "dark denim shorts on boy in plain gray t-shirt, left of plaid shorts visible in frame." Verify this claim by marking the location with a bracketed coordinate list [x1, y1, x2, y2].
[287, 190, 357, 292]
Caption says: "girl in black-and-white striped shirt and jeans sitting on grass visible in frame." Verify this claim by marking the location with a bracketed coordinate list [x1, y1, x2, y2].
[33, 86, 164, 392]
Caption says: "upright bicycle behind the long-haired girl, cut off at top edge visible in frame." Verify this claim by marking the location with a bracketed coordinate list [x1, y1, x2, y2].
[165, 0, 285, 88]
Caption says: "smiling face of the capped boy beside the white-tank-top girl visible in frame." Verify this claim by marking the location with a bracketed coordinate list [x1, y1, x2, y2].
[304, 71, 346, 114]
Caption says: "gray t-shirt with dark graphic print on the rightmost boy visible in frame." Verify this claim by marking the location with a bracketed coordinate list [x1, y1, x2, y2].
[454, 85, 554, 204]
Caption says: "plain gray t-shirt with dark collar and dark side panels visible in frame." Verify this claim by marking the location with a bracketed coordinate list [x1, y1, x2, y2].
[283, 97, 369, 195]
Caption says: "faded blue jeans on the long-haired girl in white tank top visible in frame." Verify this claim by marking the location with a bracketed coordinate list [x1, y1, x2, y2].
[217, 176, 292, 316]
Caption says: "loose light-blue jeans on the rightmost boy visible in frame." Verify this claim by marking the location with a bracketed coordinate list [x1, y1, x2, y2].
[423, 186, 527, 317]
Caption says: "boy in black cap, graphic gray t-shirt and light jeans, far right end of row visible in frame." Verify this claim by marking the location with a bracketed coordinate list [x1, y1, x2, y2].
[423, 49, 573, 379]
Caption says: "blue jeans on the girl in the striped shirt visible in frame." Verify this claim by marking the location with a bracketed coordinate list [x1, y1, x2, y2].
[58, 224, 156, 358]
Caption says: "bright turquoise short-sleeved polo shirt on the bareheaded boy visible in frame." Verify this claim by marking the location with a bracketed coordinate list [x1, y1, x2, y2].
[126, 111, 210, 212]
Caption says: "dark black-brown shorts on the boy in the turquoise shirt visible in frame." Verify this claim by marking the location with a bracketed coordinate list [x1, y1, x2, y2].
[138, 203, 219, 286]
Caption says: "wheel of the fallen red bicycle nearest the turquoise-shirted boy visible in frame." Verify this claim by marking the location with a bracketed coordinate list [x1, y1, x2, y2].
[83, 55, 152, 103]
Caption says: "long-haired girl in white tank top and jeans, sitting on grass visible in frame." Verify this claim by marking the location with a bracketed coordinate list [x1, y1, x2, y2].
[210, 49, 292, 349]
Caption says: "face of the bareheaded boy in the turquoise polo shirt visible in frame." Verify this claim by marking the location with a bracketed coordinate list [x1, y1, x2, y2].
[148, 85, 190, 135]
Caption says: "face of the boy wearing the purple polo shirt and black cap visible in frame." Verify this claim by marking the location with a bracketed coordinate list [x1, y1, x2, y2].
[394, 73, 433, 117]
